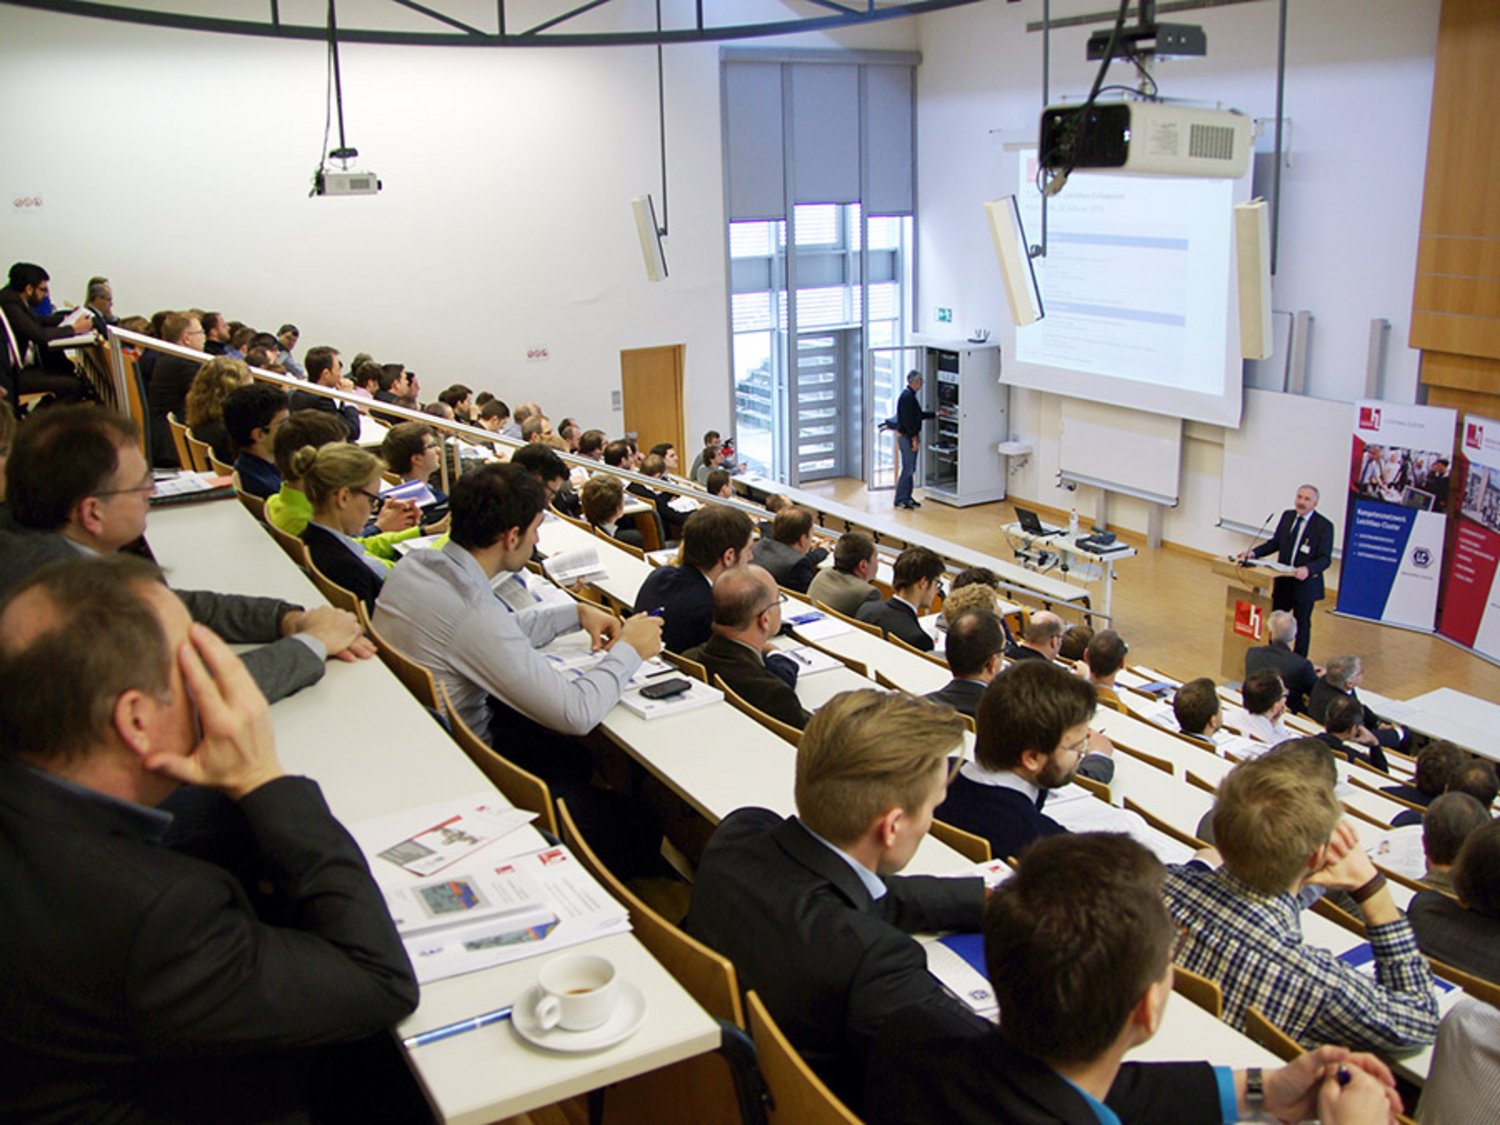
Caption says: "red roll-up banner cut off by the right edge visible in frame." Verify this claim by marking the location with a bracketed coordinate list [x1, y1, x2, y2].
[1437, 414, 1500, 657]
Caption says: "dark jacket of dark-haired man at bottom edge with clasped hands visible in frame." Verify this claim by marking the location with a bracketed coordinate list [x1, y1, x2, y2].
[866, 1014, 1221, 1125]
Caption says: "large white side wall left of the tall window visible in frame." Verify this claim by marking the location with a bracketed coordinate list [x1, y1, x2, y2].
[0, 3, 915, 443]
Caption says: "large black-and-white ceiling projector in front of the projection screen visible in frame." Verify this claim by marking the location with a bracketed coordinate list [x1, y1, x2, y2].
[1038, 102, 1256, 180]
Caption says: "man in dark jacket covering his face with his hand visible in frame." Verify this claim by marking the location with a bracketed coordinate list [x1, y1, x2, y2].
[0, 558, 417, 1121]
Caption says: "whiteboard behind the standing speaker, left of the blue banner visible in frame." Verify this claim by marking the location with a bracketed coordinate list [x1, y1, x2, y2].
[1220, 387, 1355, 539]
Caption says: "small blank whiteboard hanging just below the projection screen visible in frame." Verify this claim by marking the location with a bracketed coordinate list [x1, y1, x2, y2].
[1059, 399, 1182, 507]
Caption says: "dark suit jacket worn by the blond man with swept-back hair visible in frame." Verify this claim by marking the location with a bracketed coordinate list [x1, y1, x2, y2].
[684, 809, 989, 1113]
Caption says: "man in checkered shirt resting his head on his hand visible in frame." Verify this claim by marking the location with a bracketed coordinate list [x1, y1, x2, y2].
[1166, 740, 1437, 1050]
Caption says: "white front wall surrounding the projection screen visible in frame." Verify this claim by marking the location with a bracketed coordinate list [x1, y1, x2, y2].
[918, 0, 1439, 552]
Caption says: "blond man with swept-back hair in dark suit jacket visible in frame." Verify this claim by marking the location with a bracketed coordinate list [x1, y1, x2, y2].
[684, 692, 989, 1113]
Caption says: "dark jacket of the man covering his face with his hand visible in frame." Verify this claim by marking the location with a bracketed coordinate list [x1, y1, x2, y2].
[0, 762, 417, 1122]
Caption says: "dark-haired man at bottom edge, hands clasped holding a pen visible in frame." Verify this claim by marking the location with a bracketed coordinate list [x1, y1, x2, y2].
[866, 834, 1400, 1125]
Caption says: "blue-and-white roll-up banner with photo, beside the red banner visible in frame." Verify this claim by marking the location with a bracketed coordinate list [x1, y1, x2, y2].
[1338, 401, 1457, 630]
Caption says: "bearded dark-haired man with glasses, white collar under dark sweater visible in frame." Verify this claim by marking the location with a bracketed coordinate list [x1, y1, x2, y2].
[938, 660, 1115, 860]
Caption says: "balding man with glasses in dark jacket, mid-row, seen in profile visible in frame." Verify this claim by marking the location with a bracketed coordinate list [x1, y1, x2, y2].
[683, 566, 812, 731]
